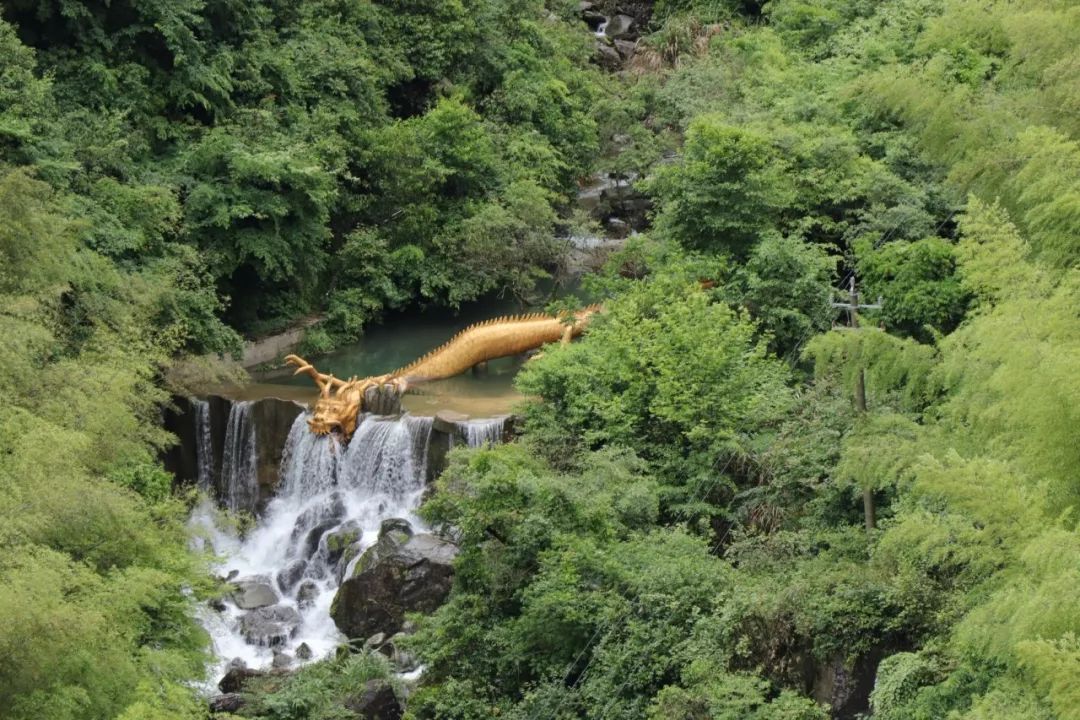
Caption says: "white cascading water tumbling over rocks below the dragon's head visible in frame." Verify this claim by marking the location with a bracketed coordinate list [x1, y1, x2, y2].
[192, 404, 432, 679]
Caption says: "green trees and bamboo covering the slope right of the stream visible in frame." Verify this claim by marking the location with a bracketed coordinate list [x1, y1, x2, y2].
[399, 0, 1080, 720]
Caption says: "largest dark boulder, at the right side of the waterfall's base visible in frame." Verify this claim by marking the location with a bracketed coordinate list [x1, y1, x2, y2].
[330, 521, 458, 638]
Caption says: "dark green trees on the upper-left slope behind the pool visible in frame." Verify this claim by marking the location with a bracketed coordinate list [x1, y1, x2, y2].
[0, 0, 600, 351]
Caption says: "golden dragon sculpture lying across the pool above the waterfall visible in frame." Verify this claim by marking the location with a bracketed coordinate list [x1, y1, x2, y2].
[285, 305, 599, 441]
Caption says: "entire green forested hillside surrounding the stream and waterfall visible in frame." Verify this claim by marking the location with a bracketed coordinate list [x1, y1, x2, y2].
[0, 0, 1080, 720]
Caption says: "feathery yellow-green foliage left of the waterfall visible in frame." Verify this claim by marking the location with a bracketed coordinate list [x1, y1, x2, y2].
[0, 169, 205, 720]
